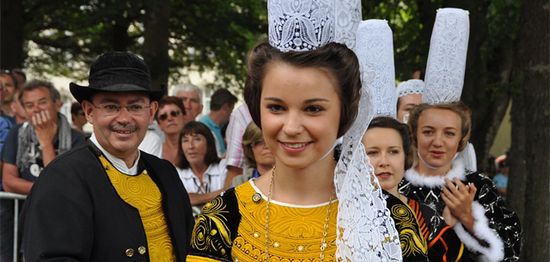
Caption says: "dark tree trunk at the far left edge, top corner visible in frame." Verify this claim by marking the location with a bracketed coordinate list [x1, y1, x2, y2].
[0, 0, 25, 69]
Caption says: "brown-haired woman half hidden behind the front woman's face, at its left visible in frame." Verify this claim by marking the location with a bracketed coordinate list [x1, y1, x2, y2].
[233, 122, 275, 186]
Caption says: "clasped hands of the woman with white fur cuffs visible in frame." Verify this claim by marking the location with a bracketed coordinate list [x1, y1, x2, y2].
[441, 178, 477, 232]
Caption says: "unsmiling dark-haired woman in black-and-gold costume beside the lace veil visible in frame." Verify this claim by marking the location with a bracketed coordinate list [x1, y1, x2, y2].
[362, 116, 434, 261]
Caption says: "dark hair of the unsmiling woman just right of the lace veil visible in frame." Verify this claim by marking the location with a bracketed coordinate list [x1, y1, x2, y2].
[367, 116, 414, 170]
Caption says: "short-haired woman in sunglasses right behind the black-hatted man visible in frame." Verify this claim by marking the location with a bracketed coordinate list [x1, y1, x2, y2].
[156, 96, 188, 166]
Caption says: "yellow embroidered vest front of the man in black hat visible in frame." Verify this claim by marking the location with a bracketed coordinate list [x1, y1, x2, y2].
[99, 156, 176, 261]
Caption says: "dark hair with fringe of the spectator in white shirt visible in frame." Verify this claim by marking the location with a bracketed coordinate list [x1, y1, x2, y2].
[176, 121, 220, 169]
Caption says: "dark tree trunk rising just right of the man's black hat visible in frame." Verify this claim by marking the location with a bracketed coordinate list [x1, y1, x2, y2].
[143, 0, 170, 93]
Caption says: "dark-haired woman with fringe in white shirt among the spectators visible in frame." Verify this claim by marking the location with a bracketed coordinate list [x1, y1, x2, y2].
[176, 121, 226, 214]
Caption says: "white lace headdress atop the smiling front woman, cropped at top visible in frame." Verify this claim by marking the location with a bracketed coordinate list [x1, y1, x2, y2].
[267, 0, 361, 52]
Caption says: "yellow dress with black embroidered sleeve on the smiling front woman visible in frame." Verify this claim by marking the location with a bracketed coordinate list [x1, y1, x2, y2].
[187, 182, 338, 261]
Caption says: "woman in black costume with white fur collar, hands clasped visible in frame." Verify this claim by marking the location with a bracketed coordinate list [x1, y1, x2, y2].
[401, 102, 521, 261]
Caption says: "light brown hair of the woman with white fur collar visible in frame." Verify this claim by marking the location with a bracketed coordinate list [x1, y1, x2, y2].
[408, 101, 472, 152]
